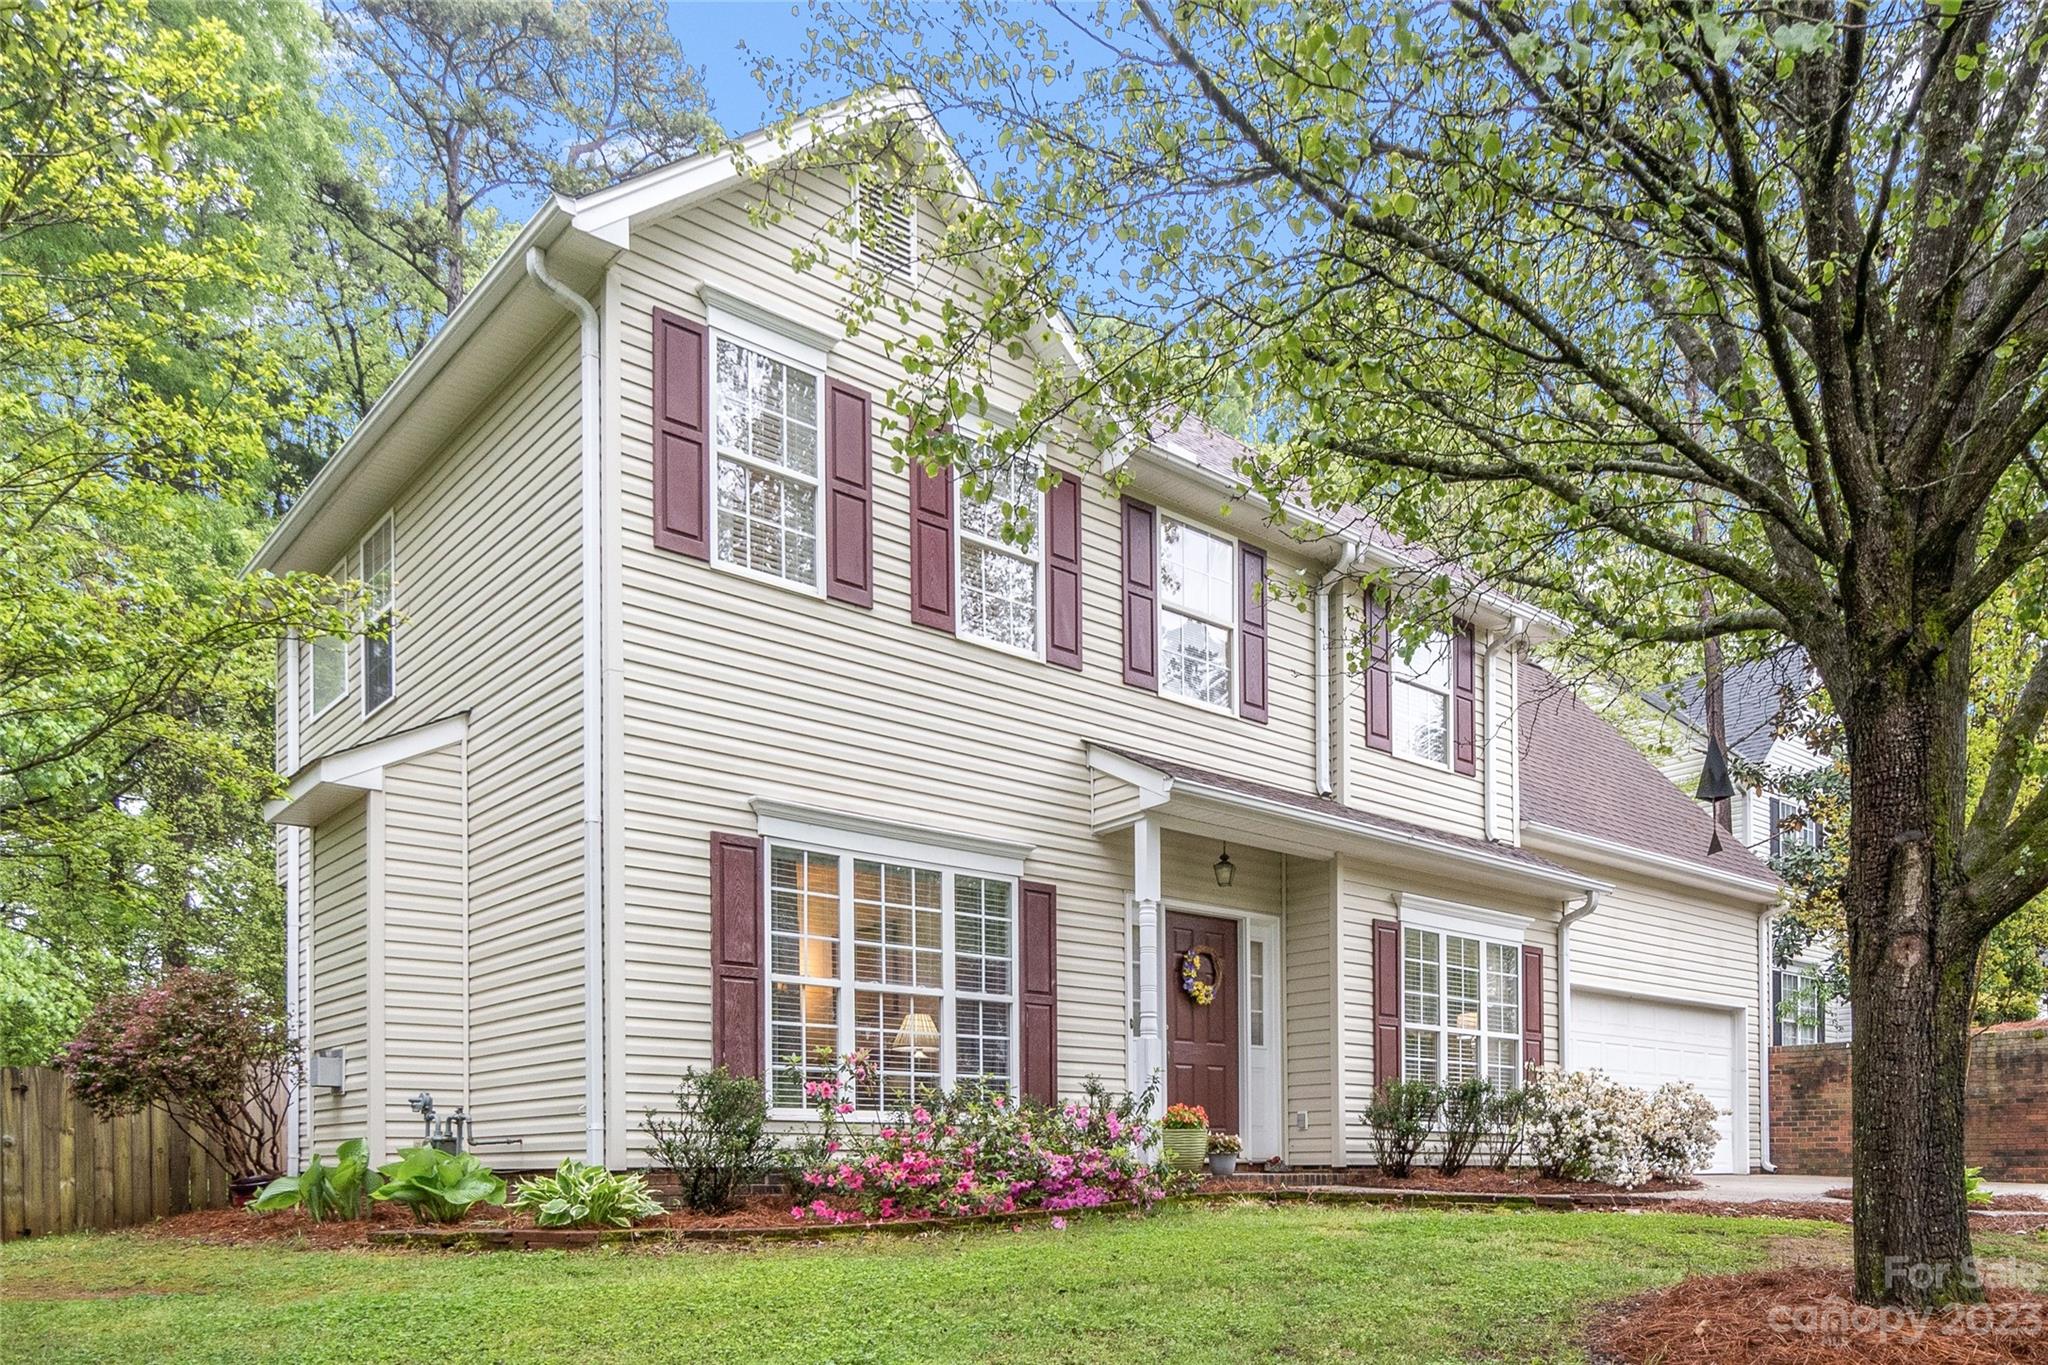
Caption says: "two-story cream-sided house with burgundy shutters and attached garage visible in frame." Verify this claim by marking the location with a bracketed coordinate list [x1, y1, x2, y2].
[256, 98, 1778, 1169]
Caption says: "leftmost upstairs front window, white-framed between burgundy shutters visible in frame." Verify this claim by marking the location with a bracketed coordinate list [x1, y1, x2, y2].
[713, 336, 819, 587]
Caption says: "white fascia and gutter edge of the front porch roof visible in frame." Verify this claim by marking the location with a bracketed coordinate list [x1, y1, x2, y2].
[1087, 743, 1608, 896]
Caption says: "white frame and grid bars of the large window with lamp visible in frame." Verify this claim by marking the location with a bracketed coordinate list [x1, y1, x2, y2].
[756, 818, 1028, 1124]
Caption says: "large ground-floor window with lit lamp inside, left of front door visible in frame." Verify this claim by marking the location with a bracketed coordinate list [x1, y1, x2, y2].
[768, 843, 1018, 1113]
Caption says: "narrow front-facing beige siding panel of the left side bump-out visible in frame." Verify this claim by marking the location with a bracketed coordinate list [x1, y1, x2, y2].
[383, 745, 469, 1140]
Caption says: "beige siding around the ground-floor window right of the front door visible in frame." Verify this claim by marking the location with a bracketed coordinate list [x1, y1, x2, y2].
[1337, 857, 1577, 1164]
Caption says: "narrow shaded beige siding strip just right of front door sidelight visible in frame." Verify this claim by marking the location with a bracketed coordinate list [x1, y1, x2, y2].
[1280, 857, 1341, 1164]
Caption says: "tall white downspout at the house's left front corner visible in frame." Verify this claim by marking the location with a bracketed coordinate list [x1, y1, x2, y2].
[526, 246, 606, 1166]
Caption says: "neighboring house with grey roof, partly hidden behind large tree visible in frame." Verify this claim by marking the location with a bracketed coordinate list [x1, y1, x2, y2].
[1645, 647, 1849, 1044]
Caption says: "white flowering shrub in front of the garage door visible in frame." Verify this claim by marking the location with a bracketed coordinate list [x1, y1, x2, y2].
[1522, 1066, 1716, 1189]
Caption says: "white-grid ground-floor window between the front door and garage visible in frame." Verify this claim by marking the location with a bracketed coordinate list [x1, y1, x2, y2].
[1401, 923, 1522, 1091]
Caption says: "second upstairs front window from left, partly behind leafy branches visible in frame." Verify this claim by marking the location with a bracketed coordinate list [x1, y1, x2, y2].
[956, 458, 1044, 655]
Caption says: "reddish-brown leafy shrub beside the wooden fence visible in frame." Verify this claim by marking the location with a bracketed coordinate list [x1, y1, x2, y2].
[55, 968, 299, 1181]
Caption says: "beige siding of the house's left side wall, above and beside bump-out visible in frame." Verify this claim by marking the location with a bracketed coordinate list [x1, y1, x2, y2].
[286, 319, 586, 1166]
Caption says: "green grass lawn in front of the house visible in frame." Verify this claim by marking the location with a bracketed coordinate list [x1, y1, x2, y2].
[0, 1203, 1845, 1365]
